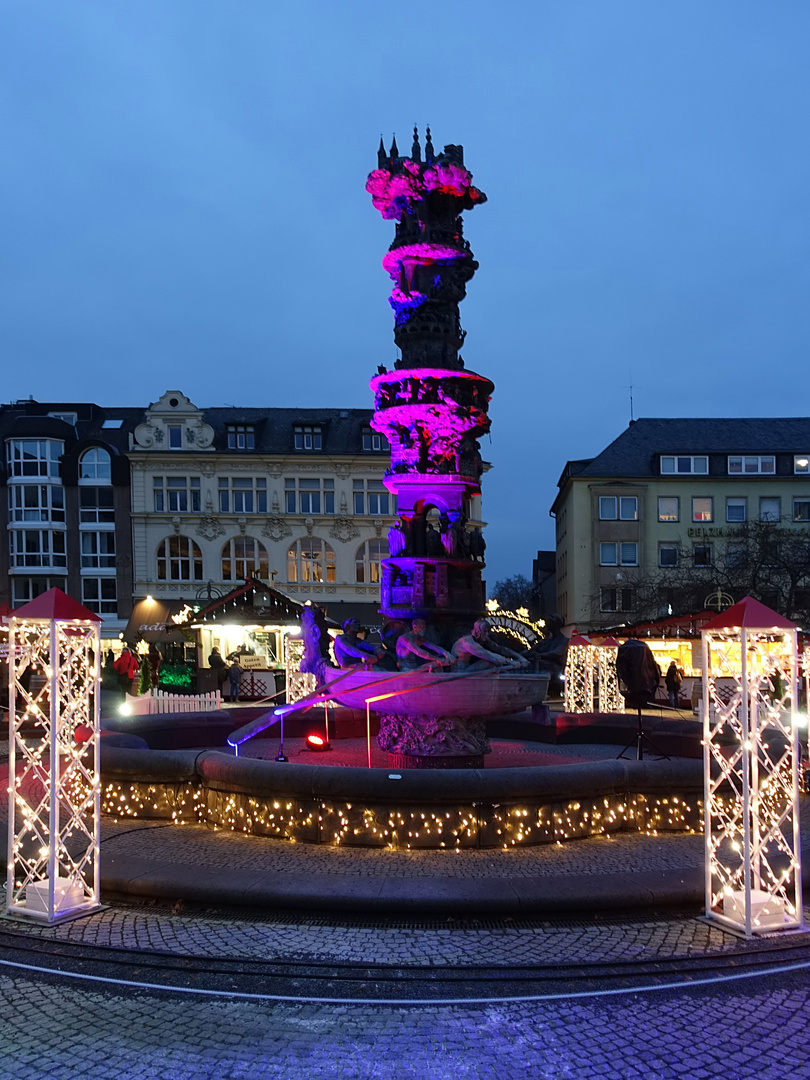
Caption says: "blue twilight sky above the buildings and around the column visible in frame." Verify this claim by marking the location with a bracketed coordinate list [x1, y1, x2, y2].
[0, 0, 810, 584]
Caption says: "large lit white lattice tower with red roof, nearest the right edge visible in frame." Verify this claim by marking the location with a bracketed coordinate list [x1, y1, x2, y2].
[701, 596, 801, 937]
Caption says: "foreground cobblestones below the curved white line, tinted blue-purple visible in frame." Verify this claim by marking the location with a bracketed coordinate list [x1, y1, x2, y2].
[0, 972, 810, 1080]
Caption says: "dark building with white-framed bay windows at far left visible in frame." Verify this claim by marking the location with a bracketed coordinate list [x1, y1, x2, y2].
[0, 400, 143, 637]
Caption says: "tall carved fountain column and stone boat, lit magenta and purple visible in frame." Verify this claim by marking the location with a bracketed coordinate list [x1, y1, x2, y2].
[319, 129, 548, 768]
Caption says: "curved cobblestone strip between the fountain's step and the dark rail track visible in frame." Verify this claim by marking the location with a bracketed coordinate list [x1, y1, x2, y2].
[7, 903, 810, 968]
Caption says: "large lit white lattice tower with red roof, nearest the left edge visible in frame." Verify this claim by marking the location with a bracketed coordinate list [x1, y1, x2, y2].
[5, 589, 102, 923]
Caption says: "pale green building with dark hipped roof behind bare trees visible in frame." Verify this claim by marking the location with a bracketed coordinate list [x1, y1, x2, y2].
[551, 418, 810, 629]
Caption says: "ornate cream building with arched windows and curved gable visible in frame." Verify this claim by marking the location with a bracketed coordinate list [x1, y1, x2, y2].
[127, 391, 396, 622]
